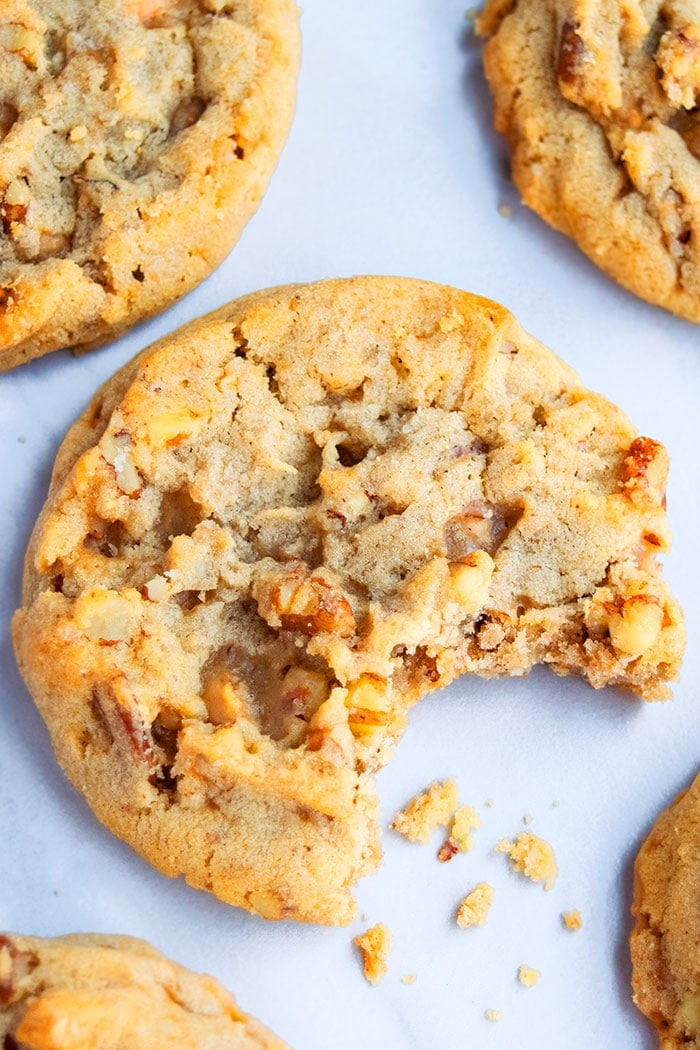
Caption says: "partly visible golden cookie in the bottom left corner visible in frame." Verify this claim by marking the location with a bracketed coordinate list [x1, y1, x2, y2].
[0, 933, 285, 1050]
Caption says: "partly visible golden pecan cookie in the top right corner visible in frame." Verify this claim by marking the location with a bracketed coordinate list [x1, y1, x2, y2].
[478, 0, 700, 321]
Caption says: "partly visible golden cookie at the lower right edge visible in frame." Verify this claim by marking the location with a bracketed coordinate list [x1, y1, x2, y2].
[630, 775, 700, 1050]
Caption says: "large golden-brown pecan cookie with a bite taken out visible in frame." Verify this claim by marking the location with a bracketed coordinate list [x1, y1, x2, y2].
[14, 277, 683, 923]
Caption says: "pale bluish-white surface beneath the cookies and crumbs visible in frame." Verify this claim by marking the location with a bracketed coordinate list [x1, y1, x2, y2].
[0, 0, 700, 1050]
